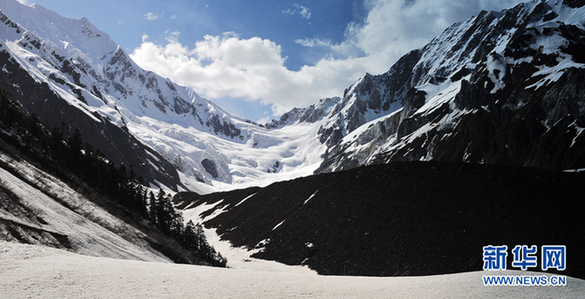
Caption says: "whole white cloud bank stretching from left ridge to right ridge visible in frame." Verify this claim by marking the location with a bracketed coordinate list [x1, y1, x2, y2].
[131, 0, 521, 115]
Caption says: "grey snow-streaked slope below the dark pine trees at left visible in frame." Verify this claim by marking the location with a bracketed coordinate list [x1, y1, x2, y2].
[0, 153, 170, 262]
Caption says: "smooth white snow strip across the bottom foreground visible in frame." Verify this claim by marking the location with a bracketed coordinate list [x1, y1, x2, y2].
[0, 241, 585, 298]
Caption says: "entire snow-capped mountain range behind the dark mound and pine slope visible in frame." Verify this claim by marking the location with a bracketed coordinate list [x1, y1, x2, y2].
[0, 0, 585, 193]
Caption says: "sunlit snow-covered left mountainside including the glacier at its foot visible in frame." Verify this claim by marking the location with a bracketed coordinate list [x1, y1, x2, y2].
[0, 0, 324, 192]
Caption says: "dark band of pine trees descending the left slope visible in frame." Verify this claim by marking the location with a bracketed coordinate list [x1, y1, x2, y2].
[0, 86, 226, 267]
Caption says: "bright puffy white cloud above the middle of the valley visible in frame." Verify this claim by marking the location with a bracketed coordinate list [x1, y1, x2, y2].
[131, 33, 362, 114]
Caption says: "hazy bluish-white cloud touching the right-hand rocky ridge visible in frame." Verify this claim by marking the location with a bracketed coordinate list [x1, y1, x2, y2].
[332, 0, 523, 73]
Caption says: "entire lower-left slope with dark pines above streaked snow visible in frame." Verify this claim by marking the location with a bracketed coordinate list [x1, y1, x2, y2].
[0, 79, 223, 265]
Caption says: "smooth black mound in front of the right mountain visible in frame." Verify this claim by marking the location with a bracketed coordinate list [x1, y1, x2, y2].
[174, 162, 585, 278]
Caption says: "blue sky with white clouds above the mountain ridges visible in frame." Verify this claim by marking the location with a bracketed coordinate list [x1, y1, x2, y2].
[19, 0, 520, 121]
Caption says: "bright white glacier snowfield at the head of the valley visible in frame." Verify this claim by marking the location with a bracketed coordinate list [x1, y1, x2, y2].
[128, 117, 326, 193]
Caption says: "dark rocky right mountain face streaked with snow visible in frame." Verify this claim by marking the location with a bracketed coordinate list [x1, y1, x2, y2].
[316, 1, 585, 173]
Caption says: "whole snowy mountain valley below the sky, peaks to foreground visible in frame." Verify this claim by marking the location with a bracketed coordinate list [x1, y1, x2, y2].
[0, 0, 585, 298]
